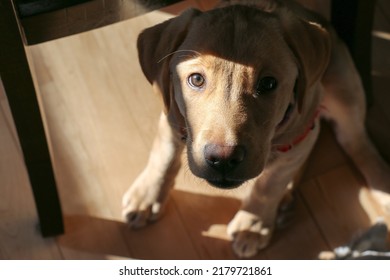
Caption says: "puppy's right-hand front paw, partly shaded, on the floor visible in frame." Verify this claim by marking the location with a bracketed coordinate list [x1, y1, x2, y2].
[227, 210, 273, 258]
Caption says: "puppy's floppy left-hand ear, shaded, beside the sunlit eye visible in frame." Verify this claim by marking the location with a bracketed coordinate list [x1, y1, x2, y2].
[137, 9, 201, 116]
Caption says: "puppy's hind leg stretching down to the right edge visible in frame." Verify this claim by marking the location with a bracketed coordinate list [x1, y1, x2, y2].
[323, 39, 390, 219]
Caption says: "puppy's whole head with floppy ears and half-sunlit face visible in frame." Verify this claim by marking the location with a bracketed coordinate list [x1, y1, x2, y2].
[138, 5, 329, 188]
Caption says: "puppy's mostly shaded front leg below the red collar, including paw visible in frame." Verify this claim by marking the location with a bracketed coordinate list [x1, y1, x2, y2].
[227, 123, 319, 258]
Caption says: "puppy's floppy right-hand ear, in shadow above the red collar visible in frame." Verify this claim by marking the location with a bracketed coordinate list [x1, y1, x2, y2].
[280, 6, 331, 112]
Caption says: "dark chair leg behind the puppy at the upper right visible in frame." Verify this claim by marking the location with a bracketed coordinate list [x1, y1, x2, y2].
[331, 0, 376, 105]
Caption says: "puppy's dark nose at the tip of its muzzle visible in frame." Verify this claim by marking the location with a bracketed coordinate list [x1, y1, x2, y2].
[204, 144, 246, 174]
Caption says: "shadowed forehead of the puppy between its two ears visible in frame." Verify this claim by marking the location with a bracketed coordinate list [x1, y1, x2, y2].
[180, 6, 289, 66]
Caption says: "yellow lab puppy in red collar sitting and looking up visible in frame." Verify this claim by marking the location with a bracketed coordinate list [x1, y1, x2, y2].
[123, 0, 390, 257]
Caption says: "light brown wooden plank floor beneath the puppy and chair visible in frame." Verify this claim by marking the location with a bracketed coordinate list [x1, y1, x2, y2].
[0, 0, 390, 259]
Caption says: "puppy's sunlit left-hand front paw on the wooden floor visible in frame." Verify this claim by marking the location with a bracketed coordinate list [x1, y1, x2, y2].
[122, 174, 164, 229]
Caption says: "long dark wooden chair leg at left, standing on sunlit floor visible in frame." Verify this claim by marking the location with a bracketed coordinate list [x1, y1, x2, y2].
[0, 0, 64, 237]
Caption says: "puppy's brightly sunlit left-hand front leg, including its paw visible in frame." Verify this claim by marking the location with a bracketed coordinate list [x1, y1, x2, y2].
[123, 113, 183, 228]
